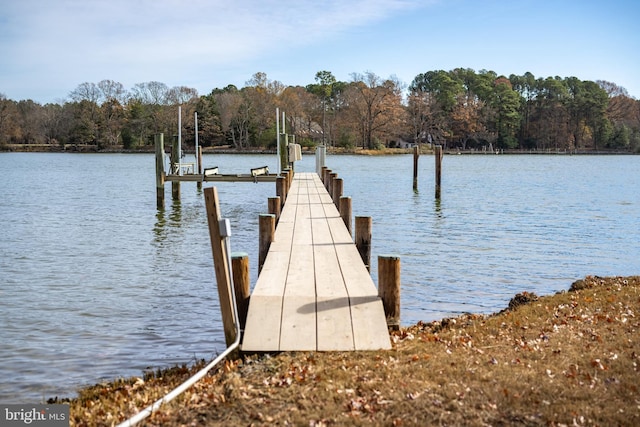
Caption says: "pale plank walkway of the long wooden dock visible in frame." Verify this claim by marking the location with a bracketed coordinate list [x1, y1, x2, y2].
[241, 173, 391, 352]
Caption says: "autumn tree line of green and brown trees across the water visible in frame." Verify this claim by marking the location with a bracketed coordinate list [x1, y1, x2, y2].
[0, 68, 640, 152]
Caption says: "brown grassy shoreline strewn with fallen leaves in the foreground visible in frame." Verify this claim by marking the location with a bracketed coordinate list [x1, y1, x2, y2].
[60, 276, 640, 426]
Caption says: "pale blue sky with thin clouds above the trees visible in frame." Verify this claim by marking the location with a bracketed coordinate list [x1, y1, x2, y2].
[0, 0, 640, 103]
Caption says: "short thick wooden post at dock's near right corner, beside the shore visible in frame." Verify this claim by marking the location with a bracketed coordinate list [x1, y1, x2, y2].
[378, 255, 400, 330]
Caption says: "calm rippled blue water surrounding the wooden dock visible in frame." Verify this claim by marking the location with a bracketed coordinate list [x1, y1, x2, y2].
[0, 153, 640, 403]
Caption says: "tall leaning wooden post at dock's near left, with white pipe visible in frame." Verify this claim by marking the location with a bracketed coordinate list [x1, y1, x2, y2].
[204, 187, 237, 346]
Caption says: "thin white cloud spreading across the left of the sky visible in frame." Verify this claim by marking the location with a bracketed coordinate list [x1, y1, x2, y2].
[0, 0, 424, 101]
